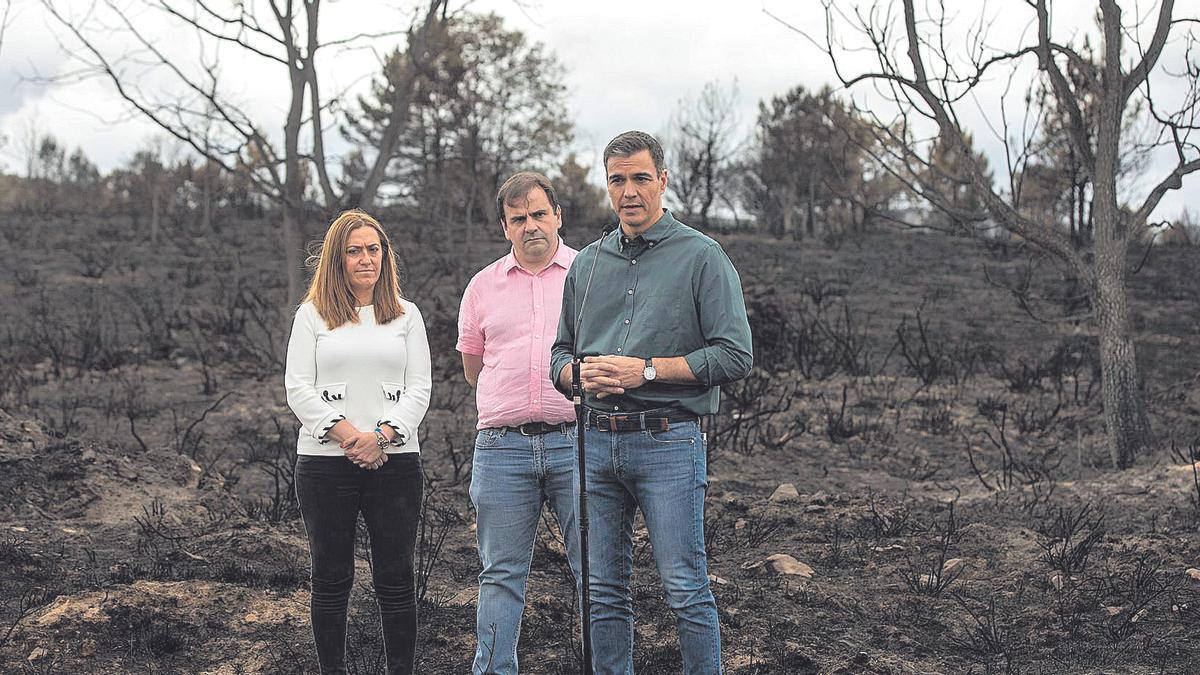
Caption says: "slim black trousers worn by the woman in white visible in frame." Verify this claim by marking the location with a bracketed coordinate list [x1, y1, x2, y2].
[295, 453, 424, 675]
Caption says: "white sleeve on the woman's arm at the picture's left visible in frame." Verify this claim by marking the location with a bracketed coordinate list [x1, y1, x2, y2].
[283, 304, 344, 438]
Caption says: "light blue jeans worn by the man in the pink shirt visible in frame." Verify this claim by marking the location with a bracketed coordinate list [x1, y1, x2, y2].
[470, 428, 580, 674]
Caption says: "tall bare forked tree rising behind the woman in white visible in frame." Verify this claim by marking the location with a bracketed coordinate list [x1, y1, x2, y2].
[42, 0, 449, 304]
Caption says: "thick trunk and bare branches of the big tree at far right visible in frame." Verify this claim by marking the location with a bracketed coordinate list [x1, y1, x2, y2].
[814, 0, 1200, 467]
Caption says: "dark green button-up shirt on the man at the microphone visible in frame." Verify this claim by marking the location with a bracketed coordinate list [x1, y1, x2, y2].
[550, 211, 754, 414]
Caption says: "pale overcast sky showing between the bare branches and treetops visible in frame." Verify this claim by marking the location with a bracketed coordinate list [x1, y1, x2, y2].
[0, 0, 1200, 217]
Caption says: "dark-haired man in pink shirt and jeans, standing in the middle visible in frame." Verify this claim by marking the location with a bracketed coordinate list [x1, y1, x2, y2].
[457, 172, 580, 674]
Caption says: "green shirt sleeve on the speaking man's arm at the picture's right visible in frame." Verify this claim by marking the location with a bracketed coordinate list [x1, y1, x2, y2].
[684, 244, 754, 387]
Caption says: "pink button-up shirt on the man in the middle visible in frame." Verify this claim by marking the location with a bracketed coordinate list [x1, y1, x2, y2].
[455, 239, 577, 429]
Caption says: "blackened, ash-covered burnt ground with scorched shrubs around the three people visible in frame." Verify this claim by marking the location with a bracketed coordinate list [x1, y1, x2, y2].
[0, 219, 1200, 675]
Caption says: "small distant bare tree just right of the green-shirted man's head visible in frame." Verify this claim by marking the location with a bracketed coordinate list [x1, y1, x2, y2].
[667, 82, 742, 228]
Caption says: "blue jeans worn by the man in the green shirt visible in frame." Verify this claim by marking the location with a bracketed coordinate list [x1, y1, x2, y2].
[584, 422, 721, 675]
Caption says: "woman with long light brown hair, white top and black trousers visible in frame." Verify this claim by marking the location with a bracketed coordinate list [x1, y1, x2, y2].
[283, 209, 431, 674]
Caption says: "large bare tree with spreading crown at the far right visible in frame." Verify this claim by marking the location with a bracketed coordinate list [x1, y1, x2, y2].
[780, 0, 1200, 467]
